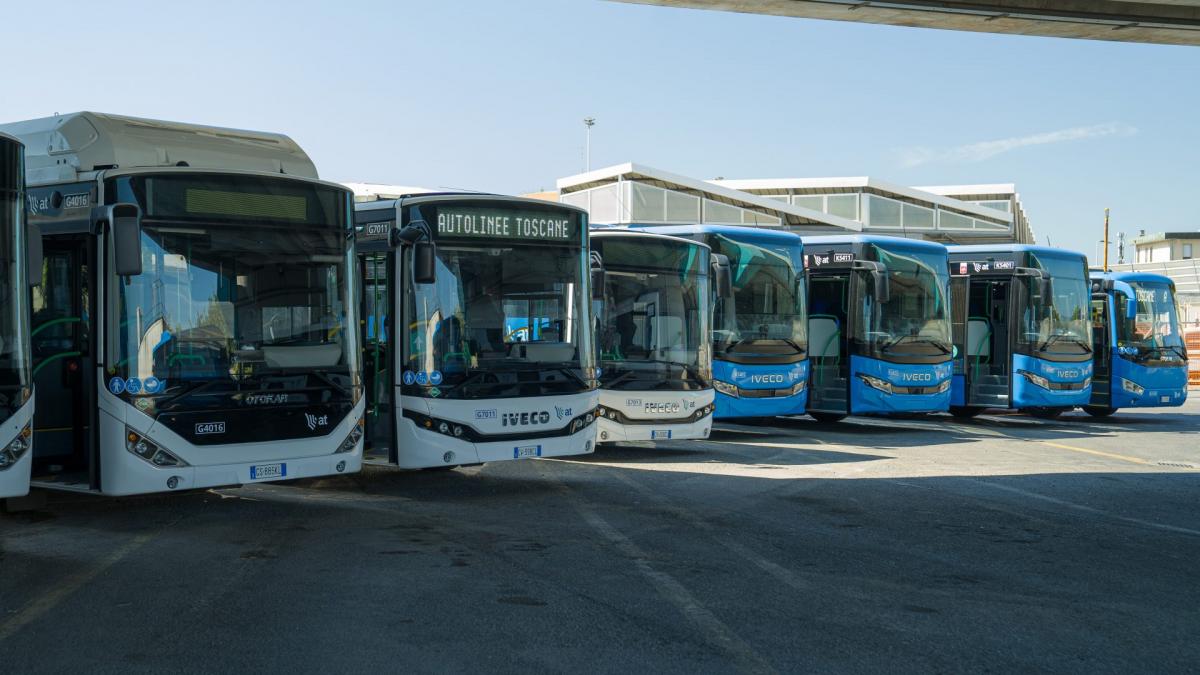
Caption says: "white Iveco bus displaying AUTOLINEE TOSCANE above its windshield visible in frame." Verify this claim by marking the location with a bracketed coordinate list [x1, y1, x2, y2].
[356, 186, 599, 468]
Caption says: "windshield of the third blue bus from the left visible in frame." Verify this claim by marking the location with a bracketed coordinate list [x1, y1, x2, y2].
[1019, 253, 1092, 357]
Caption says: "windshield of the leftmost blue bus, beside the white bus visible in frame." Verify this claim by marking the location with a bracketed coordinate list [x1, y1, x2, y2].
[707, 234, 809, 358]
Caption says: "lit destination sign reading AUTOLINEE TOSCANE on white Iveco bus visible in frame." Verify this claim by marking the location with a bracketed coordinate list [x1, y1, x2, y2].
[437, 207, 580, 241]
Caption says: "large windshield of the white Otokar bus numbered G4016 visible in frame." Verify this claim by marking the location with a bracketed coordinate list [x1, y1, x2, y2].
[107, 174, 359, 412]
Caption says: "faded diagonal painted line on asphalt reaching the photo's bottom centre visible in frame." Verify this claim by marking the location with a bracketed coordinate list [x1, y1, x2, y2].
[547, 476, 778, 673]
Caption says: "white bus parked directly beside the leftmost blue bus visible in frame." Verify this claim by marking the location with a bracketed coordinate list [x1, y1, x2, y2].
[592, 229, 710, 443]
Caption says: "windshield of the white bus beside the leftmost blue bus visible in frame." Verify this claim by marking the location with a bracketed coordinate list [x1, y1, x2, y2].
[593, 237, 712, 390]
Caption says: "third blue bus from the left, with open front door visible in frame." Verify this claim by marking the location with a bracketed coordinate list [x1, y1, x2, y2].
[949, 244, 1092, 418]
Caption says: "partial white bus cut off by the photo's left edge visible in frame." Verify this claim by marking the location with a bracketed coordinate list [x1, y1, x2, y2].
[0, 133, 41, 498]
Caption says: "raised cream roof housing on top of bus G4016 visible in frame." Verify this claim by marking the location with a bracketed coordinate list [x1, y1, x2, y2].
[0, 112, 318, 185]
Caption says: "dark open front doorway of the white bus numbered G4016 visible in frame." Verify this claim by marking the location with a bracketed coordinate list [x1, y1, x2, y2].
[30, 235, 100, 489]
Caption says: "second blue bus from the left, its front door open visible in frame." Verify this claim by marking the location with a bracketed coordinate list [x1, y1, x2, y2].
[804, 234, 953, 422]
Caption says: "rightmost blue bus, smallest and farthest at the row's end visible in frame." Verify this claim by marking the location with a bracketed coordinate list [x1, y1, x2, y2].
[1084, 270, 1188, 417]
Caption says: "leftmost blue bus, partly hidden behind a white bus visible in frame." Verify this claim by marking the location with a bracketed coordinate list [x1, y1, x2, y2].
[632, 225, 809, 419]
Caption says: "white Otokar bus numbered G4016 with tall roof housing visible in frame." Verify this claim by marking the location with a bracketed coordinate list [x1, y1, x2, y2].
[0, 113, 364, 495]
